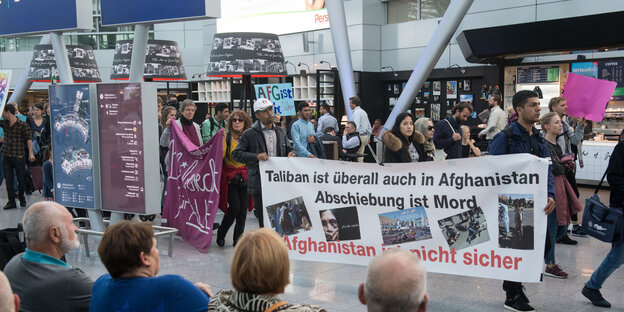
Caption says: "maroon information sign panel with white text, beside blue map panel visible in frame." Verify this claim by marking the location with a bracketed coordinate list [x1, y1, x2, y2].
[97, 83, 146, 214]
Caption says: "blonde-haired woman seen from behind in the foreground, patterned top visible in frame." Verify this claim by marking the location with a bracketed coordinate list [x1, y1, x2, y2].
[208, 228, 326, 312]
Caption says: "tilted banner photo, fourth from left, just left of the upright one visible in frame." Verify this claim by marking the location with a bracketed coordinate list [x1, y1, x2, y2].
[438, 207, 490, 250]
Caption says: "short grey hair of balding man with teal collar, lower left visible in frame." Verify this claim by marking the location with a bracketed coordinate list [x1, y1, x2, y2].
[22, 201, 63, 245]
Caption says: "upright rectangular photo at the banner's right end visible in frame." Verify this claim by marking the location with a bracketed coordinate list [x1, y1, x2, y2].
[498, 194, 535, 250]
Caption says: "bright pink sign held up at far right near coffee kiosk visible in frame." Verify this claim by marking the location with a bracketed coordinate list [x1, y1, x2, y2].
[562, 73, 617, 122]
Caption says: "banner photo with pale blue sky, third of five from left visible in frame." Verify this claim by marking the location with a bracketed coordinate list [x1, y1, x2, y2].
[379, 207, 432, 246]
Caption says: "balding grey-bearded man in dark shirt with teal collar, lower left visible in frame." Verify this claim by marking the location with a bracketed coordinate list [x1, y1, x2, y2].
[4, 201, 93, 312]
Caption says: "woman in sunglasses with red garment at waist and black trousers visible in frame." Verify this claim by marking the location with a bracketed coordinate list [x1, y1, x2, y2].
[217, 110, 253, 247]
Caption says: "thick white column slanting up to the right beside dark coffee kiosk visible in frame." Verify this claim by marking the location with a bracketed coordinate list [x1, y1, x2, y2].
[380, 0, 473, 132]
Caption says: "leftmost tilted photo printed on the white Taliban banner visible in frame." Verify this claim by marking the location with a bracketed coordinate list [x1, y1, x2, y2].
[266, 196, 312, 236]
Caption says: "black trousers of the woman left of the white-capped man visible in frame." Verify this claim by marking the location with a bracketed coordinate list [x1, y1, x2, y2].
[217, 183, 249, 242]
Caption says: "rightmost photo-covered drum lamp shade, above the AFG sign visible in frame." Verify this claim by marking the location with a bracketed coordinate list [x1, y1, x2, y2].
[207, 33, 287, 77]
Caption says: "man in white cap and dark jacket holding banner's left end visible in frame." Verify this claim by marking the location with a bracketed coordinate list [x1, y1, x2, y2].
[232, 98, 295, 227]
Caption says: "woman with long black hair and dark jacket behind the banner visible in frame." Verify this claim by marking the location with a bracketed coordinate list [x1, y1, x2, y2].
[382, 113, 429, 163]
